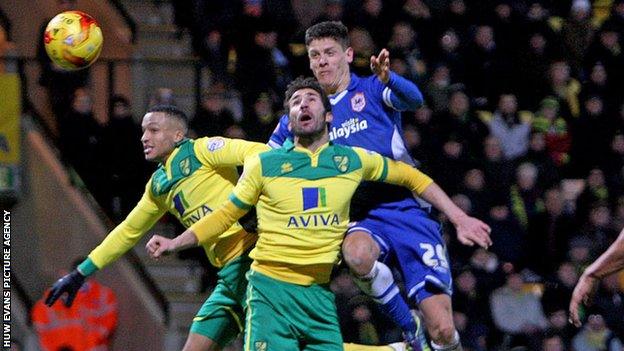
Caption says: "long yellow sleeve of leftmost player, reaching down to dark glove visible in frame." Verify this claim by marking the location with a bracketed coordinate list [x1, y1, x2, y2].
[89, 179, 167, 269]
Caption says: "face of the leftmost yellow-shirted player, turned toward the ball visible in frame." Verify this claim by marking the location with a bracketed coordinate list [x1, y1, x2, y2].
[141, 112, 184, 162]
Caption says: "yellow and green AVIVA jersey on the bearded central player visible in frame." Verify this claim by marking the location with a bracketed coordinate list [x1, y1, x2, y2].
[191, 141, 432, 285]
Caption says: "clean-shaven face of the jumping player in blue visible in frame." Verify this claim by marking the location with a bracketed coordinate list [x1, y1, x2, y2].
[308, 38, 353, 94]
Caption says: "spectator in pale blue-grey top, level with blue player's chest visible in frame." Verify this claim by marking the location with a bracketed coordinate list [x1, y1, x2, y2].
[489, 94, 531, 160]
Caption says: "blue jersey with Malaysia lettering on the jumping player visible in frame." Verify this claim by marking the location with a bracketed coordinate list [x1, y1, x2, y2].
[269, 73, 430, 220]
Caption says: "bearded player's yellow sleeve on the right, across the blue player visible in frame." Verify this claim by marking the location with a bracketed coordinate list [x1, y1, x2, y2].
[353, 147, 433, 194]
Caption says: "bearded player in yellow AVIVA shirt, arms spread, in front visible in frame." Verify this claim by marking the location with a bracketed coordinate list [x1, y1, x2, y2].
[146, 78, 489, 351]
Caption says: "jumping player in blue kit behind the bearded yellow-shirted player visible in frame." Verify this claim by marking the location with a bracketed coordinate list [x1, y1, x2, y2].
[269, 22, 491, 350]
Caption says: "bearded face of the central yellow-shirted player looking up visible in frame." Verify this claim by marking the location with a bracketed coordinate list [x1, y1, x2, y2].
[288, 88, 331, 137]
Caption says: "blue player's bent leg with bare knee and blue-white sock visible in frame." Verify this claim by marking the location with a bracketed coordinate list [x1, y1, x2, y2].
[342, 226, 426, 350]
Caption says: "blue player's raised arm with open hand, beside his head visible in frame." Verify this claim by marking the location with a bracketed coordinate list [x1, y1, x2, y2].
[370, 49, 424, 111]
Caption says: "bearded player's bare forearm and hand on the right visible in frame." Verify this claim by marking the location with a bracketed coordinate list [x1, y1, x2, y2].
[420, 183, 492, 249]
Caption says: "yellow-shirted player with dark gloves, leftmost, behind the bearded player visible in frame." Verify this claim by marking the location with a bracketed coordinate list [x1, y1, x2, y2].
[46, 106, 400, 351]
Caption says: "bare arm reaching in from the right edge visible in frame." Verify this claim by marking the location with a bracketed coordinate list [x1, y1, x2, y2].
[569, 229, 624, 327]
